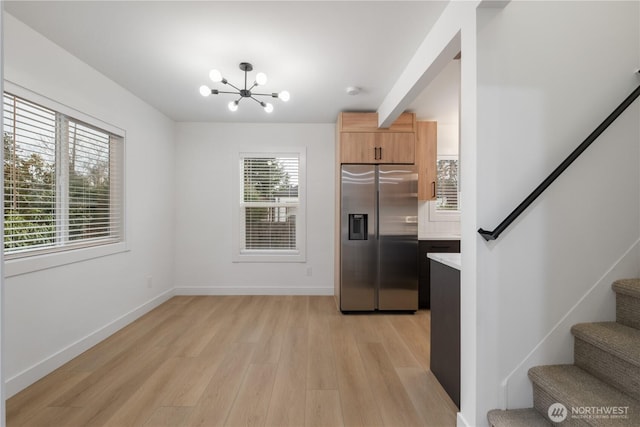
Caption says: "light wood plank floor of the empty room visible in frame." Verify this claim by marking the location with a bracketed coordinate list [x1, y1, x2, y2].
[7, 296, 457, 427]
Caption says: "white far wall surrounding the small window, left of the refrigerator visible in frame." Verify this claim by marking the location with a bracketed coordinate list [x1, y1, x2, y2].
[175, 120, 335, 295]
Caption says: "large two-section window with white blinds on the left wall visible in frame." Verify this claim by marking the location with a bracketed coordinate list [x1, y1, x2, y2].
[3, 93, 123, 259]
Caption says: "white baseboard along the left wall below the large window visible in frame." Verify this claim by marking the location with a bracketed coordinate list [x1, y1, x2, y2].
[5, 289, 175, 399]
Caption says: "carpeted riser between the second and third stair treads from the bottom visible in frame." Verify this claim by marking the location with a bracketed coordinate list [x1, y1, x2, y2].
[574, 337, 640, 400]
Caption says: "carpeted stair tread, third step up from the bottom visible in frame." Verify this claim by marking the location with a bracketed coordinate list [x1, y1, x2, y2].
[571, 322, 640, 366]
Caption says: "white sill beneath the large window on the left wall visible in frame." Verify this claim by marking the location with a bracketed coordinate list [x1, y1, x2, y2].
[4, 242, 128, 277]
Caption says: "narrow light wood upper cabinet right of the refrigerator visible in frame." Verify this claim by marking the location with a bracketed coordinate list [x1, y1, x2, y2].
[416, 122, 438, 200]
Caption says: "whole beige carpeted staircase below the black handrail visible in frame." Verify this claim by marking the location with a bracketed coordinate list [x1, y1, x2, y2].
[487, 279, 640, 427]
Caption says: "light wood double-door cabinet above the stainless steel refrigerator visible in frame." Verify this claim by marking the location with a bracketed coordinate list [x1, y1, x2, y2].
[336, 113, 416, 164]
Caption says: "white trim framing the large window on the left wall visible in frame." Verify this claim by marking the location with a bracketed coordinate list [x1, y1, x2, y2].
[2, 80, 129, 277]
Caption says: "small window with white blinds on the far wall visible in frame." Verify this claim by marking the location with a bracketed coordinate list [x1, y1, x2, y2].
[237, 153, 304, 261]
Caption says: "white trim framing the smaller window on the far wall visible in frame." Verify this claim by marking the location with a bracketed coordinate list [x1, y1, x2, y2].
[231, 147, 307, 262]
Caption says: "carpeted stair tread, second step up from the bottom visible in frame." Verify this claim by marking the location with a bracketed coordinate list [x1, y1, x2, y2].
[529, 365, 640, 426]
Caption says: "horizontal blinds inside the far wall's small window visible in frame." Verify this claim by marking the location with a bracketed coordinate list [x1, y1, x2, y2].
[240, 156, 300, 251]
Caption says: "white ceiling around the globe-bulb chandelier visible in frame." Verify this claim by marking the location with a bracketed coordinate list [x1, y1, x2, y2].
[3, 0, 457, 123]
